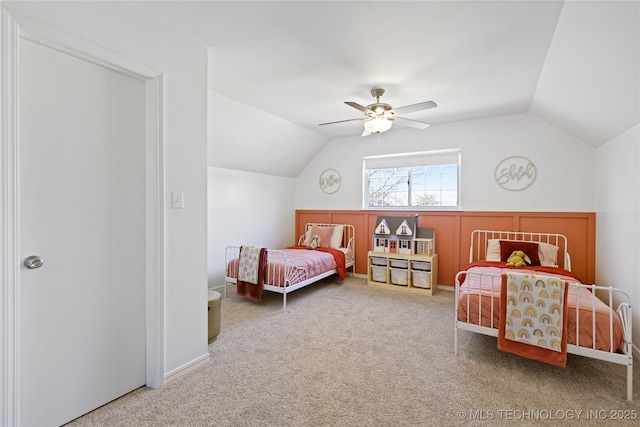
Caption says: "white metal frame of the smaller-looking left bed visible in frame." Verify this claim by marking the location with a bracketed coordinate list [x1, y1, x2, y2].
[224, 223, 356, 310]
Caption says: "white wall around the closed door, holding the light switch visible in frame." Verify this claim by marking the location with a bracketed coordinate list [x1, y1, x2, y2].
[3, 2, 208, 373]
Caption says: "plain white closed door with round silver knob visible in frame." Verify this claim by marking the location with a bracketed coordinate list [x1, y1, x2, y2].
[18, 40, 145, 426]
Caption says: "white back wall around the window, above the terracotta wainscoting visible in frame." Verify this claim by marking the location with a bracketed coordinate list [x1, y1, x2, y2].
[296, 114, 595, 212]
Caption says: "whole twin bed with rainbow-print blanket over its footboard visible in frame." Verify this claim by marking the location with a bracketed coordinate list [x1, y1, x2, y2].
[454, 230, 633, 400]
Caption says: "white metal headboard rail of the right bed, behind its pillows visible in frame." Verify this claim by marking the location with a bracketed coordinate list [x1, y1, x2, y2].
[469, 230, 571, 270]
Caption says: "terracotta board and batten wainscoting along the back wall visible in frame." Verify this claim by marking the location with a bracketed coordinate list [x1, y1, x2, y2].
[296, 210, 596, 286]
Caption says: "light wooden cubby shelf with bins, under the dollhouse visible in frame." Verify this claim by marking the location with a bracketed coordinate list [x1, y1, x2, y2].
[367, 251, 438, 295]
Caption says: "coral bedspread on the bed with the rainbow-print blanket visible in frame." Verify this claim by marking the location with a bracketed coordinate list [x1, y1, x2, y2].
[458, 261, 624, 351]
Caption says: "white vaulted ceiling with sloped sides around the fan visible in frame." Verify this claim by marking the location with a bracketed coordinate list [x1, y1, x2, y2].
[136, 1, 640, 176]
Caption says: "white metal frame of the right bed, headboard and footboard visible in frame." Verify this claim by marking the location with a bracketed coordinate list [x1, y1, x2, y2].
[454, 230, 633, 401]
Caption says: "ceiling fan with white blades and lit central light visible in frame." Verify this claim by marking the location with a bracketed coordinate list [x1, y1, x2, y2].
[319, 88, 437, 136]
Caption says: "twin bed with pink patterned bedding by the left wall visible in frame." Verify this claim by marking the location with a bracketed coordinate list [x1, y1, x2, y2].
[225, 223, 355, 310]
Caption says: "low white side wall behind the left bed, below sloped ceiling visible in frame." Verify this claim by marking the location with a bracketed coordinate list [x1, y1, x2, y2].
[208, 167, 296, 288]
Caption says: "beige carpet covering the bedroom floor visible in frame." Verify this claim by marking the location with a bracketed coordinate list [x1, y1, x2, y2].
[70, 277, 640, 427]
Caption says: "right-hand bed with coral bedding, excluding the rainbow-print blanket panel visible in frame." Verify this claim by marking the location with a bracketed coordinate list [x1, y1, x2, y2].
[454, 230, 633, 400]
